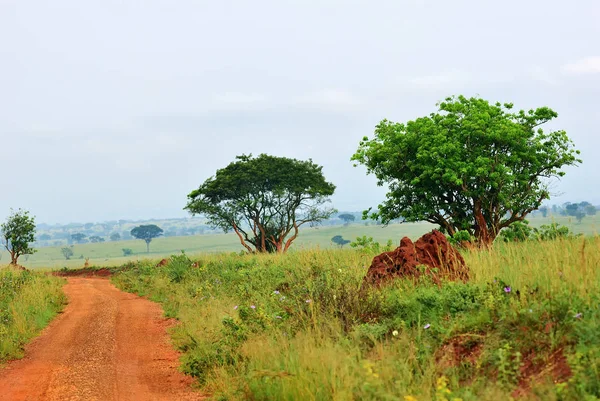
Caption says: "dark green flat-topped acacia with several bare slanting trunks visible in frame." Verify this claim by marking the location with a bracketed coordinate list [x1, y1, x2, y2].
[184, 154, 336, 253]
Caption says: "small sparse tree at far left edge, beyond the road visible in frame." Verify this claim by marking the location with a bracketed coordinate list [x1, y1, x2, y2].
[0, 209, 36, 265]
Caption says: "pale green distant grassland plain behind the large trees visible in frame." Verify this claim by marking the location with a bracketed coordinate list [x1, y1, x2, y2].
[0, 216, 600, 268]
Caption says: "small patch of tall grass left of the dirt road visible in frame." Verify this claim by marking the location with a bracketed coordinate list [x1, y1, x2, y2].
[0, 268, 66, 364]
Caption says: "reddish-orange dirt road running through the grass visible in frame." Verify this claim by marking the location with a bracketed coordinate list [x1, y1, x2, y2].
[0, 278, 202, 401]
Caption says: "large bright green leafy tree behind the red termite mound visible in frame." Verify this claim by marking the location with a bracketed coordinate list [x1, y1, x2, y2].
[352, 96, 581, 246]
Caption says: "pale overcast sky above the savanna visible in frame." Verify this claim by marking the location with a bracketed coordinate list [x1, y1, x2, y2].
[0, 0, 600, 223]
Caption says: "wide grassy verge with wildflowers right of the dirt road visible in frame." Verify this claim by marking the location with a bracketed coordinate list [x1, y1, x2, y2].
[113, 237, 600, 401]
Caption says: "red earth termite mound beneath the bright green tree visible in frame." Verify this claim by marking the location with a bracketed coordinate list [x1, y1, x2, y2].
[365, 230, 469, 286]
